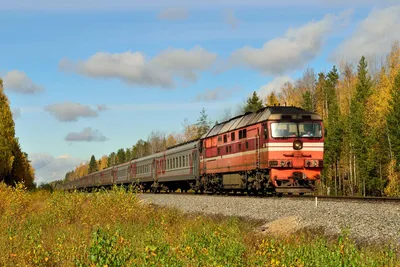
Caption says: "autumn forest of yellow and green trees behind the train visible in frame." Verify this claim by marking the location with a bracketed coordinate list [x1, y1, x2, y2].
[65, 42, 400, 196]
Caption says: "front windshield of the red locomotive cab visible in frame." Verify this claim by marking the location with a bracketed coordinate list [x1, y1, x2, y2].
[271, 122, 322, 138]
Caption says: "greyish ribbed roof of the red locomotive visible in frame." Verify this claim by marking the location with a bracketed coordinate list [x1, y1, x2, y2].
[201, 106, 322, 139]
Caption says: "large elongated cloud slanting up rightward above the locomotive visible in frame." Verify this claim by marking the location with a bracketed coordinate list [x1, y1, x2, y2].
[230, 11, 350, 75]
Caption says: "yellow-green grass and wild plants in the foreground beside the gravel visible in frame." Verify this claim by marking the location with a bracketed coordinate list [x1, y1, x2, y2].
[0, 184, 400, 266]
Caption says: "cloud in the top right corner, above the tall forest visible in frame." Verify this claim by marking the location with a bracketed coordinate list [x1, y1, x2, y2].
[331, 5, 400, 62]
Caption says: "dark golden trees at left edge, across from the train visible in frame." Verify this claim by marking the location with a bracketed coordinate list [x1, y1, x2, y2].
[0, 79, 36, 189]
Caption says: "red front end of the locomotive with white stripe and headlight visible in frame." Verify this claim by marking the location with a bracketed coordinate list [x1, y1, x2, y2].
[264, 114, 324, 193]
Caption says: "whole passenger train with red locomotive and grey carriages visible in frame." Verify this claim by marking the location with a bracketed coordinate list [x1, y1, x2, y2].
[62, 106, 324, 195]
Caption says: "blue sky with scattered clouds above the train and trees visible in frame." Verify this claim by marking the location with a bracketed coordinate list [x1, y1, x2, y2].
[0, 0, 400, 183]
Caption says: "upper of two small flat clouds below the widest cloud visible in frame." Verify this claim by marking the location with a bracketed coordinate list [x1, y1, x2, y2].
[44, 102, 99, 122]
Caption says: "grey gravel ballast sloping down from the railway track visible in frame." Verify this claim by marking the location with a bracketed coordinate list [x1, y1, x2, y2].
[140, 194, 400, 244]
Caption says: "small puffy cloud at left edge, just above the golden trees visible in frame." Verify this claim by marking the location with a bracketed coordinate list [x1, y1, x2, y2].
[3, 70, 44, 94]
